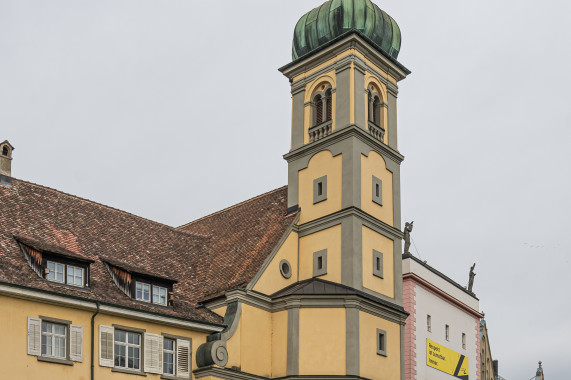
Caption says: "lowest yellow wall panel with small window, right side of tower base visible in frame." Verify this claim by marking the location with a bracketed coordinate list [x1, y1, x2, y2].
[359, 311, 401, 380]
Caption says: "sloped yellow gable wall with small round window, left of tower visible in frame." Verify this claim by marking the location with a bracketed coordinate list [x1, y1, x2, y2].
[254, 232, 298, 295]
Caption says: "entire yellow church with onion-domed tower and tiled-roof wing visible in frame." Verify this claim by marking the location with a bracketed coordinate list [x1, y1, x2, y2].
[0, 0, 418, 380]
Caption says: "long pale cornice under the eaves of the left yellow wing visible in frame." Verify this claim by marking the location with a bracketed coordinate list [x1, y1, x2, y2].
[0, 283, 224, 333]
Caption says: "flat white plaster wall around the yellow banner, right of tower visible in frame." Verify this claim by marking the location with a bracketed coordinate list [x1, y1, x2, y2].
[415, 284, 477, 380]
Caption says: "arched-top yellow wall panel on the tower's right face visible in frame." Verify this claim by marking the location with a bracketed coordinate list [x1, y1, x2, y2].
[361, 151, 394, 226]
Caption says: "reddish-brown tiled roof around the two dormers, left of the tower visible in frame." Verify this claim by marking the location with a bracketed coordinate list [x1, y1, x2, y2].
[0, 179, 294, 323]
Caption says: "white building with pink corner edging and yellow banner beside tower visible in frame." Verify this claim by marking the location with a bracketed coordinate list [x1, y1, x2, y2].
[402, 254, 482, 380]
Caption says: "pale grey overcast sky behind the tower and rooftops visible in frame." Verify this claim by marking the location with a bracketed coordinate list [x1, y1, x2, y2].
[0, 0, 571, 380]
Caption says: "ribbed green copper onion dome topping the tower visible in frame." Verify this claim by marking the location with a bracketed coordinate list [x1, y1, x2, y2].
[292, 0, 401, 60]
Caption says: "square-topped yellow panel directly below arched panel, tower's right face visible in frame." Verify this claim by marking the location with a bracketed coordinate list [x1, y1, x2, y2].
[362, 226, 395, 298]
